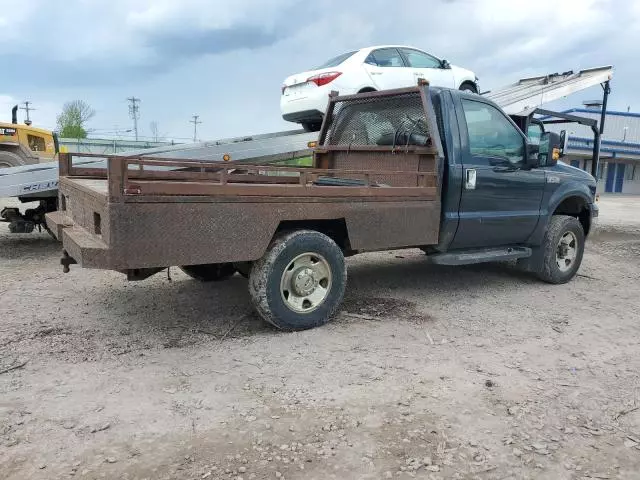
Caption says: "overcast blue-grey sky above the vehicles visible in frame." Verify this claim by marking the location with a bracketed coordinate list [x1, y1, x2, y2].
[0, 0, 640, 139]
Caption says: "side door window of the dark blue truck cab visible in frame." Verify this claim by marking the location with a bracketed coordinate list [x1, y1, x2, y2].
[462, 100, 524, 165]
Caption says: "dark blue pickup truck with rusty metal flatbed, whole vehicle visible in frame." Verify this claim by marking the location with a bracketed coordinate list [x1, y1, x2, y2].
[46, 81, 598, 330]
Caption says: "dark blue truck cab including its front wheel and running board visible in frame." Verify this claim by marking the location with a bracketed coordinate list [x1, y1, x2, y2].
[425, 88, 598, 283]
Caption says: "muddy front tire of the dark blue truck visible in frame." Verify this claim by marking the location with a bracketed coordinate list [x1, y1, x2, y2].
[537, 215, 585, 284]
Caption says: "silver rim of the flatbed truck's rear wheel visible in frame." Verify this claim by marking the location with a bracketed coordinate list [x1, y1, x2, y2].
[280, 253, 331, 313]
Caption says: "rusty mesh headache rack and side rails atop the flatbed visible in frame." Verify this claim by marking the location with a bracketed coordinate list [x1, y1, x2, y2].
[59, 84, 442, 202]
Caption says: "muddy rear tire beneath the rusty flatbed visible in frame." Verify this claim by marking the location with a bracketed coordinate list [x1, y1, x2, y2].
[249, 230, 347, 331]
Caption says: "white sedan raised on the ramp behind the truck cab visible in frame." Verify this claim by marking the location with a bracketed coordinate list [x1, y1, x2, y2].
[280, 45, 479, 131]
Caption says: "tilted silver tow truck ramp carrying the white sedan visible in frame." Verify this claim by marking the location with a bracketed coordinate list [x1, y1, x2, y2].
[0, 65, 613, 197]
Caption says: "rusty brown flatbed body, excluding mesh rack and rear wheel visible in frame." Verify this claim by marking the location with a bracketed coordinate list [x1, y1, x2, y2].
[48, 146, 440, 270]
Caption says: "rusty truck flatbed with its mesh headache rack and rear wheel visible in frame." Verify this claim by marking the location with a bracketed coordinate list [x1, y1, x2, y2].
[47, 86, 444, 329]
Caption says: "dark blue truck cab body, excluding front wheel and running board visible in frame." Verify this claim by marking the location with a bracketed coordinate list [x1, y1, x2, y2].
[432, 88, 598, 258]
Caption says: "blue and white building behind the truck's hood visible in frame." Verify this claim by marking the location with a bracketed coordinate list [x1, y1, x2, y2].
[547, 102, 640, 195]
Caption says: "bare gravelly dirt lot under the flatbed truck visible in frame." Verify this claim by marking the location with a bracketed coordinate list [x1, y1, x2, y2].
[0, 197, 640, 480]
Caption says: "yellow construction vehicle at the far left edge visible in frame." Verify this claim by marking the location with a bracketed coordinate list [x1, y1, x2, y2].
[0, 105, 59, 168]
